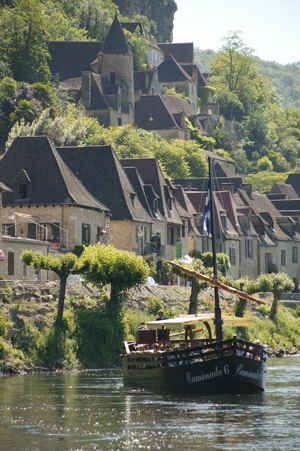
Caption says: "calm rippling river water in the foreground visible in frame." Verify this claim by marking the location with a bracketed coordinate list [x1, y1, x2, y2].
[0, 357, 300, 451]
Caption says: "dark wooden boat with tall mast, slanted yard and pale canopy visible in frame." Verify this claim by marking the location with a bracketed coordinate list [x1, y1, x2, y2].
[123, 159, 266, 394]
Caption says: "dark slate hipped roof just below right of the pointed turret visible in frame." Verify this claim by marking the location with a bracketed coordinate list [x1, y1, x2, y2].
[135, 95, 178, 130]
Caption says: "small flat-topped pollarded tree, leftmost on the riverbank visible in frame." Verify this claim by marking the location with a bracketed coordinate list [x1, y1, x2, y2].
[21, 250, 78, 325]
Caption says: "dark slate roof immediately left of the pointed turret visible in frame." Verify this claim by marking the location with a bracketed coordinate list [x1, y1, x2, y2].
[48, 41, 103, 80]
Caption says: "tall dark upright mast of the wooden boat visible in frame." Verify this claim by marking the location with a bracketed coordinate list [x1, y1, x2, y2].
[208, 157, 223, 341]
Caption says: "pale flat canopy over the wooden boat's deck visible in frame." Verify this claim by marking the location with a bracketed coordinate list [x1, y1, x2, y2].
[146, 312, 251, 329]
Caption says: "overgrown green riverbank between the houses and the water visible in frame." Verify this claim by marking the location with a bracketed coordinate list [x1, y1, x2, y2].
[0, 281, 300, 374]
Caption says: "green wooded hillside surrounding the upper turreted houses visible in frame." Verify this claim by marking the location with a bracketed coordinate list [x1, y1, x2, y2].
[0, 0, 300, 185]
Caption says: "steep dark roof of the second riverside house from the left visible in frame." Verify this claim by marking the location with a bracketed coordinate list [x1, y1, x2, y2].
[57, 146, 152, 222]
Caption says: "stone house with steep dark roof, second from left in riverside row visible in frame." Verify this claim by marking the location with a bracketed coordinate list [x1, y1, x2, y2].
[57, 146, 153, 255]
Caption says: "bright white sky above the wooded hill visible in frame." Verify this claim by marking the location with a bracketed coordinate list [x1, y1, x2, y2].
[173, 0, 300, 64]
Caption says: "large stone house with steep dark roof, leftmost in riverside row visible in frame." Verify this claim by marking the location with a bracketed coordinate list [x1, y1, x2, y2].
[0, 137, 110, 250]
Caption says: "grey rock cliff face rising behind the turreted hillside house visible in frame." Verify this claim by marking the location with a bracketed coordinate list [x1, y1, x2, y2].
[114, 0, 177, 42]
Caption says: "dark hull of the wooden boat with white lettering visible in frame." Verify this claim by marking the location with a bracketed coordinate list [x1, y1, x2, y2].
[124, 355, 265, 394]
